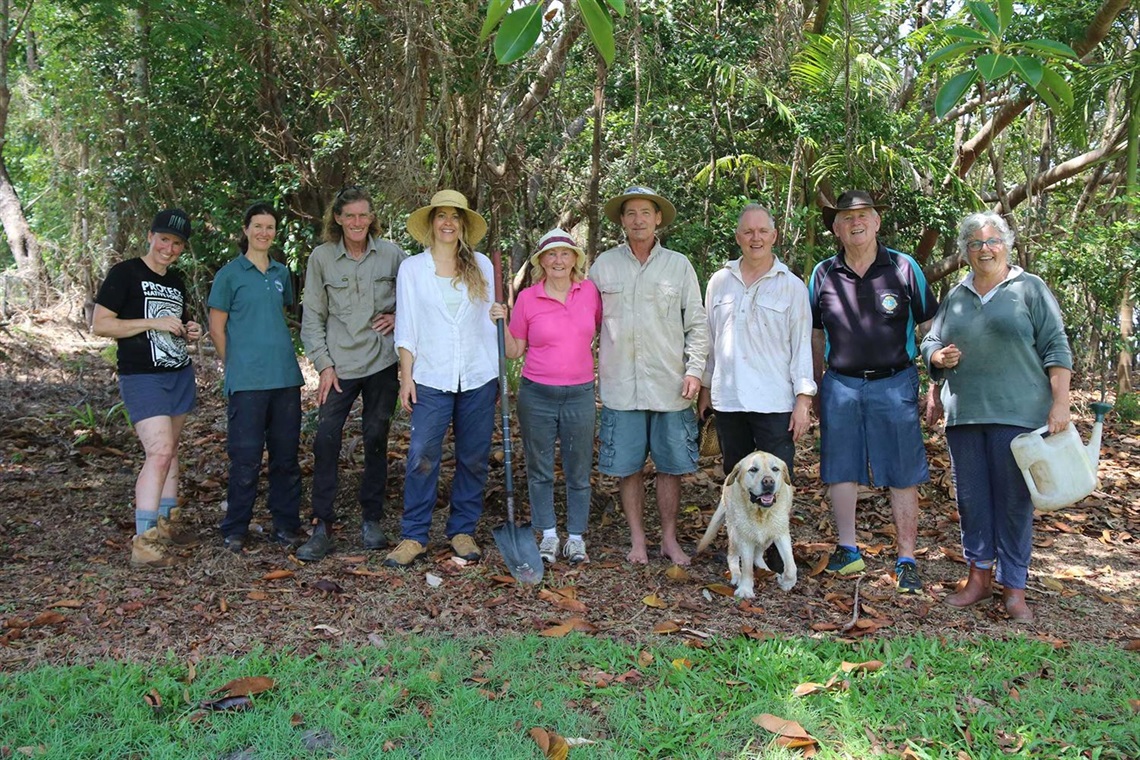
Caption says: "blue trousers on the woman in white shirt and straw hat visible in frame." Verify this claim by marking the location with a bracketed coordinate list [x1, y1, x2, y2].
[400, 381, 498, 545]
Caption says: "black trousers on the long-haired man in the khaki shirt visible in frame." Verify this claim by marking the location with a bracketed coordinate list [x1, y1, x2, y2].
[312, 365, 400, 523]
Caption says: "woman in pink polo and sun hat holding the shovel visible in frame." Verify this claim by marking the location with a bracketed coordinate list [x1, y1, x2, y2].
[491, 229, 602, 563]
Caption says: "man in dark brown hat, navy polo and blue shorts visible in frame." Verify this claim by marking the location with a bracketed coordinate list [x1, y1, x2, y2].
[808, 190, 938, 594]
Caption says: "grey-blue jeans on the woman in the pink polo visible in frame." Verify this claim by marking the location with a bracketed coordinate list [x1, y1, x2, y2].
[519, 377, 597, 536]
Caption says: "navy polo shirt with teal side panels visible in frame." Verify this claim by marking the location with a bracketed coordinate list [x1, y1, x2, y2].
[808, 243, 938, 373]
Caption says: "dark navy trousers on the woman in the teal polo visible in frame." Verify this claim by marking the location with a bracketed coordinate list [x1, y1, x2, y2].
[221, 387, 301, 536]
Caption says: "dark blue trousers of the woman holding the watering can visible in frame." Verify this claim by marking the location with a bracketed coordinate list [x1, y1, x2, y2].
[946, 425, 1033, 588]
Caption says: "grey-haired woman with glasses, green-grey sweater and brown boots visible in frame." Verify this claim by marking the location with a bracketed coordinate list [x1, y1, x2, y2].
[922, 212, 1073, 622]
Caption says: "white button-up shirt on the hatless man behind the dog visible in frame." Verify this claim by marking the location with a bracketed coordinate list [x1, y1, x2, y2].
[701, 259, 816, 414]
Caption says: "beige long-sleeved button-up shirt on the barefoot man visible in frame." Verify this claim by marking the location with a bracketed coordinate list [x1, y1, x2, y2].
[589, 243, 708, 411]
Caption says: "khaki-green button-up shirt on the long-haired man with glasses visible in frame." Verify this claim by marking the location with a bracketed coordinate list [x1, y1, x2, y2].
[301, 237, 407, 379]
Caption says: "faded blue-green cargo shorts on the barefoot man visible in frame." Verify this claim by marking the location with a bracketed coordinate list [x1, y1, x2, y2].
[597, 407, 697, 477]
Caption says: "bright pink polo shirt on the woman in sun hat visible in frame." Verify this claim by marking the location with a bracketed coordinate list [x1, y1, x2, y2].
[511, 280, 602, 385]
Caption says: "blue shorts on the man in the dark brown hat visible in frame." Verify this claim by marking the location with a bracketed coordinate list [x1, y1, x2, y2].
[820, 367, 930, 488]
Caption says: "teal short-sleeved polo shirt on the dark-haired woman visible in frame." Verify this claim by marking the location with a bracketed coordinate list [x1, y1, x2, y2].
[206, 255, 304, 397]
